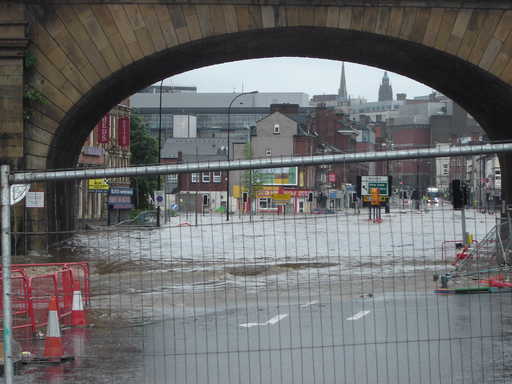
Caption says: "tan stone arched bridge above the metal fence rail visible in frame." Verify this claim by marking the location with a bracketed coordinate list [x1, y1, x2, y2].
[0, 0, 512, 238]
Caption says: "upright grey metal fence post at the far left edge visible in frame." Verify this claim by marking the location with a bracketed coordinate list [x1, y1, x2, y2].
[0, 165, 14, 384]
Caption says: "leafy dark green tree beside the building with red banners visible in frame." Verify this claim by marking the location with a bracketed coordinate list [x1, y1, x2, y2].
[130, 115, 158, 208]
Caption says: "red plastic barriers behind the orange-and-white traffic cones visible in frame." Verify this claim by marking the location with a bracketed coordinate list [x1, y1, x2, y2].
[0, 262, 90, 333]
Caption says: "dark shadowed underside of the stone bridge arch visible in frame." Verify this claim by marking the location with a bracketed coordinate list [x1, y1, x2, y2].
[47, 27, 512, 207]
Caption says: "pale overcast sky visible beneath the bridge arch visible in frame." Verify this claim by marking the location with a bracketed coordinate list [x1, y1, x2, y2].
[169, 57, 432, 101]
